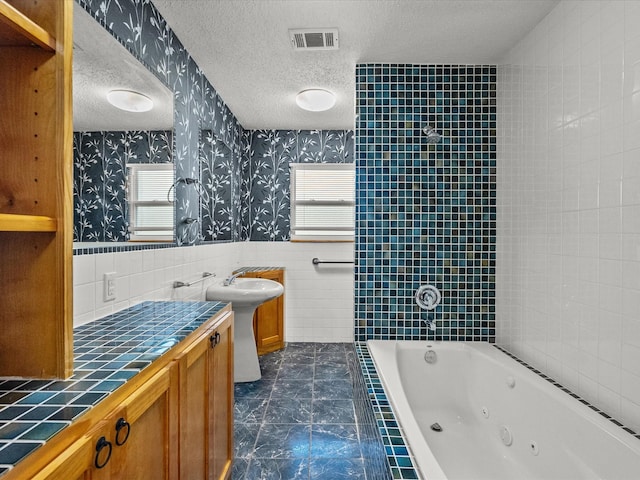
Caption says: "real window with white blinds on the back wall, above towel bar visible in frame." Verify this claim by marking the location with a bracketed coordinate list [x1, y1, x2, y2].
[291, 163, 355, 241]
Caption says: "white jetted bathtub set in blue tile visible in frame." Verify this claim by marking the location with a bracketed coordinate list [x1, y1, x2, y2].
[367, 340, 640, 480]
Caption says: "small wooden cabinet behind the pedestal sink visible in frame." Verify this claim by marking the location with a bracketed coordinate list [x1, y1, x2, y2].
[242, 269, 284, 355]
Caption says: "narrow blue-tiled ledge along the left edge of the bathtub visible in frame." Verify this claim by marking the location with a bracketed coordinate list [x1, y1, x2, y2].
[355, 342, 422, 480]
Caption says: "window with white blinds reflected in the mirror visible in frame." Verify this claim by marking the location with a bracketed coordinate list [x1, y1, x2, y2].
[127, 163, 174, 241]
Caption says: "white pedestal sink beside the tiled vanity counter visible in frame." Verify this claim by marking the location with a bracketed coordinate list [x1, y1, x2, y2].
[206, 277, 284, 382]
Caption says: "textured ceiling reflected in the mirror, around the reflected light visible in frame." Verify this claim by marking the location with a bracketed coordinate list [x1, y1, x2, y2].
[73, 7, 173, 132]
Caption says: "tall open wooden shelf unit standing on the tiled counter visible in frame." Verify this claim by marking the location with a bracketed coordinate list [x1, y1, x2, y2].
[0, 0, 74, 378]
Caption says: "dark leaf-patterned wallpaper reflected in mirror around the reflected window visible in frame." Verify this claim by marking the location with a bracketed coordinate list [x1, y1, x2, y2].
[73, 131, 173, 242]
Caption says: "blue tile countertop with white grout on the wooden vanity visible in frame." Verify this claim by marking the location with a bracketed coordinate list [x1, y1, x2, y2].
[0, 301, 227, 475]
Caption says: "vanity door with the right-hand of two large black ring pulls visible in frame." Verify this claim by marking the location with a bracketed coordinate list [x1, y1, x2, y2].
[105, 367, 178, 480]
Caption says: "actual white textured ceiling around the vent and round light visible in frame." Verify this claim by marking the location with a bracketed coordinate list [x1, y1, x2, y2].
[153, 0, 558, 129]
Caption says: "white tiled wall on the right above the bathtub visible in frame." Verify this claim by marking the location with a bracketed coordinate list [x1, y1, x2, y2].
[496, 0, 640, 431]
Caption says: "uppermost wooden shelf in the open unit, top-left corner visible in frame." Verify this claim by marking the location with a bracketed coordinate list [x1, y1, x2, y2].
[0, 0, 56, 52]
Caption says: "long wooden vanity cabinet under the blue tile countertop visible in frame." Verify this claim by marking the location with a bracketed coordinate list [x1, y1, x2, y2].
[8, 306, 233, 480]
